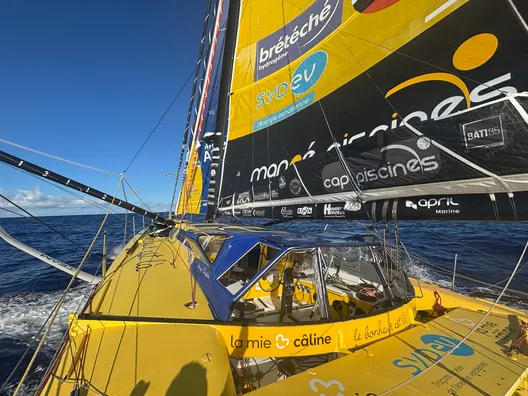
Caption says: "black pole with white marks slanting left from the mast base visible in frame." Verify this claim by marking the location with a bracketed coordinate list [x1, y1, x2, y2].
[0, 150, 170, 224]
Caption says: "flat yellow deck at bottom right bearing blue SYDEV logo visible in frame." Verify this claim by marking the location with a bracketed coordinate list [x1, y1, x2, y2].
[252, 308, 528, 396]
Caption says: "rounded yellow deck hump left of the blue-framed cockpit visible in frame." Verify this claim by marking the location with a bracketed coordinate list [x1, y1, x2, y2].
[83, 237, 213, 319]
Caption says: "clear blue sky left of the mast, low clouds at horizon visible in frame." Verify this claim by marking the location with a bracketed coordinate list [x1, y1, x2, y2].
[0, 0, 210, 216]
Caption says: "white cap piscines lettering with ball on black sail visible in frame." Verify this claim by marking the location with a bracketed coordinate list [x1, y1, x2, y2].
[323, 137, 440, 192]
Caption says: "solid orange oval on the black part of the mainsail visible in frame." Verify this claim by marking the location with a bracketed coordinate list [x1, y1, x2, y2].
[453, 33, 499, 71]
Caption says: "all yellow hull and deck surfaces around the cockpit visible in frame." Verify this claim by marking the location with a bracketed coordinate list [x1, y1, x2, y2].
[39, 230, 528, 396]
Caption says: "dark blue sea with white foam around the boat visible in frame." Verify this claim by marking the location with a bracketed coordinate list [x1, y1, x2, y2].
[0, 215, 528, 395]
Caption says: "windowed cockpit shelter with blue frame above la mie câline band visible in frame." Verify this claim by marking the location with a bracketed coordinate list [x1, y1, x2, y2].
[175, 226, 414, 324]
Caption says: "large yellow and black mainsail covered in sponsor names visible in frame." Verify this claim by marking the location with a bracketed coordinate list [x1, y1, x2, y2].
[213, 0, 528, 220]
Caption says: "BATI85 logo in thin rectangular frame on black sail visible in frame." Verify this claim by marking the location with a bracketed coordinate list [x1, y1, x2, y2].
[462, 115, 504, 150]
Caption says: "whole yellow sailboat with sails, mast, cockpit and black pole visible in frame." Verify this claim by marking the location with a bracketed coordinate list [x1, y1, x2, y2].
[0, 0, 528, 396]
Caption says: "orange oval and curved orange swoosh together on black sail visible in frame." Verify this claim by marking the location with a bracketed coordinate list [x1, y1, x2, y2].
[385, 33, 499, 109]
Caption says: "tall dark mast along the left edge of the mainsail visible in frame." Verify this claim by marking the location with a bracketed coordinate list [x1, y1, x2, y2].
[205, 0, 240, 221]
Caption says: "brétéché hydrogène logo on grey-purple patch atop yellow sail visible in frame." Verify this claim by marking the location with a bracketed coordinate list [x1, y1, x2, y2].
[254, 0, 343, 81]
